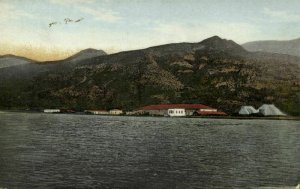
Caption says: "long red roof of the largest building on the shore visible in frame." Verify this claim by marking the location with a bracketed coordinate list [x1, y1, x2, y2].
[141, 104, 213, 110]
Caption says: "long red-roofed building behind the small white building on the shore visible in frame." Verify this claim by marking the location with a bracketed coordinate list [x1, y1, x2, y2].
[140, 104, 221, 116]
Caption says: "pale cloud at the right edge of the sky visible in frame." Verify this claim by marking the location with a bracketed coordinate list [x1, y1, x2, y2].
[263, 8, 300, 22]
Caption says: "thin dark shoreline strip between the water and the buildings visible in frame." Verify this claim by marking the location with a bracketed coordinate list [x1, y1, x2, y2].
[0, 110, 300, 121]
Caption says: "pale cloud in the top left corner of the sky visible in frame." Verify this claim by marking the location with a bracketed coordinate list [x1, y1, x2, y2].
[0, 1, 34, 22]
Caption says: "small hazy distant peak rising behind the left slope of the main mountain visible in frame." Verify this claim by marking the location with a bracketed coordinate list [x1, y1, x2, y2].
[66, 48, 107, 62]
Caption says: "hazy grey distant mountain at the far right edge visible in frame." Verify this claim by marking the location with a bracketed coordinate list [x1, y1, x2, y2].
[243, 38, 300, 57]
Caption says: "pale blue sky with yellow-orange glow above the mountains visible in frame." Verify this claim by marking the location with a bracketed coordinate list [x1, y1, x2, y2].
[0, 0, 300, 61]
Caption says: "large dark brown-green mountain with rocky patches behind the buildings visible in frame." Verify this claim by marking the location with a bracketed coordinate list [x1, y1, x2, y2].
[0, 36, 300, 115]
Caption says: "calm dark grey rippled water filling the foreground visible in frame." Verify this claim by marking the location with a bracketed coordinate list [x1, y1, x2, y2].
[0, 112, 300, 189]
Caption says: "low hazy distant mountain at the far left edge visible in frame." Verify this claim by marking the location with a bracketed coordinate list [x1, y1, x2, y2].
[0, 55, 33, 68]
